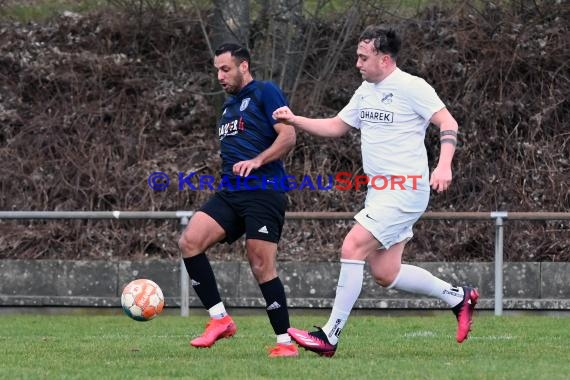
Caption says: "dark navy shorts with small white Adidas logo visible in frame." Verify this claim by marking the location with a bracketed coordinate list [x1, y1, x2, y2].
[200, 190, 287, 244]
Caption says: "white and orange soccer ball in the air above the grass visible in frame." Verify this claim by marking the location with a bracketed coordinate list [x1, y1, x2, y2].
[121, 278, 164, 321]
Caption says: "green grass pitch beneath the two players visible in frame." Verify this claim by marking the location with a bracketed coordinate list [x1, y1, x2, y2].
[0, 311, 570, 380]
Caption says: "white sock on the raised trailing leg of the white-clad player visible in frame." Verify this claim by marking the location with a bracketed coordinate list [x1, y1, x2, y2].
[388, 264, 463, 307]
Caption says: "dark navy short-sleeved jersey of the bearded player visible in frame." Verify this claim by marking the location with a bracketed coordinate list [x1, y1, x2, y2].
[218, 80, 288, 191]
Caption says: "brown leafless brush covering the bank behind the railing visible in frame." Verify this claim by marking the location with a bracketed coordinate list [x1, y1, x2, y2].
[0, 0, 570, 261]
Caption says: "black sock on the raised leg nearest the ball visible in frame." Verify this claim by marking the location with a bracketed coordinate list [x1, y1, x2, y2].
[184, 253, 222, 309]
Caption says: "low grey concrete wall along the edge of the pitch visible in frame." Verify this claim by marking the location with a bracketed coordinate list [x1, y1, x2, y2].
[0, 260, 570, 310]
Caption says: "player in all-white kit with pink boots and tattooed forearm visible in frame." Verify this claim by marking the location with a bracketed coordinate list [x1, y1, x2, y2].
[273, 26, 479, 357]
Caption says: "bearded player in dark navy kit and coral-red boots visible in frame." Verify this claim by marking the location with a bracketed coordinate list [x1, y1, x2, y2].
[178, 43, 298, 357]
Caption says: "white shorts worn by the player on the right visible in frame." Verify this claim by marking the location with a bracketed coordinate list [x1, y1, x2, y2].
[354, 189, 429, 249]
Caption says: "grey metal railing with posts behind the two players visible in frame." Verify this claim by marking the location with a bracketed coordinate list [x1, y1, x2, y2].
[0, 211, 570, 316]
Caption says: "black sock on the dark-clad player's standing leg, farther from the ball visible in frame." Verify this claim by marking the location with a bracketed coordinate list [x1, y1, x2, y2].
[259, 277, 291, 335]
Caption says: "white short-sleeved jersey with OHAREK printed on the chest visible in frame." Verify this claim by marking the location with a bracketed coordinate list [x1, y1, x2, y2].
[339, 68, 445, 192]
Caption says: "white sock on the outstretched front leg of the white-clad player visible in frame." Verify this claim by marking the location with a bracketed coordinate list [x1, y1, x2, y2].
[323, 259, 364, 344]
